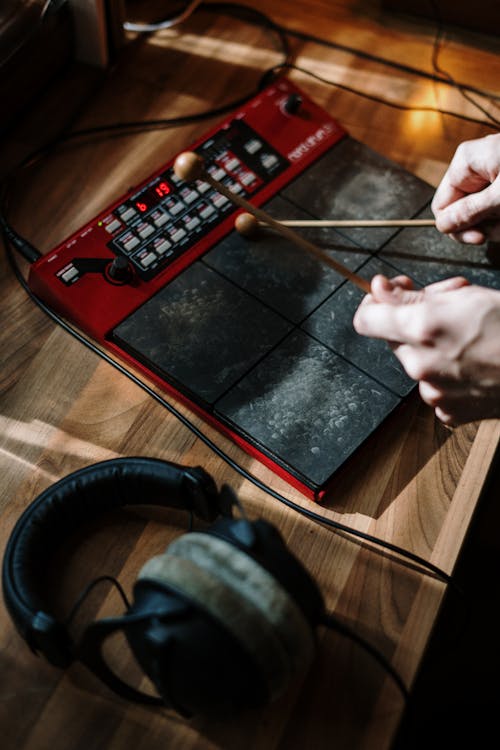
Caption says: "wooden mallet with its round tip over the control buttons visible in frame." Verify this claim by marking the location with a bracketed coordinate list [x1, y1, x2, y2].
[174, 151, 370, 294]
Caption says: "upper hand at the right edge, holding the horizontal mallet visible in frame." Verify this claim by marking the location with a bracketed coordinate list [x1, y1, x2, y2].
[432, 133, 500, 245]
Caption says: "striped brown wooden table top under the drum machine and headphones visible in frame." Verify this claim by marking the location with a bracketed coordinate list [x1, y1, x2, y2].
[0, 0, 500, 750]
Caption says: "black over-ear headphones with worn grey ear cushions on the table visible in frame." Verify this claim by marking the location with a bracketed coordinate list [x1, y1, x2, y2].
[2, 458, 324, 716]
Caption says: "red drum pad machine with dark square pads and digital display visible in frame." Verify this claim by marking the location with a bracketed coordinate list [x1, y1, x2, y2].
[29, 79, 500, 499]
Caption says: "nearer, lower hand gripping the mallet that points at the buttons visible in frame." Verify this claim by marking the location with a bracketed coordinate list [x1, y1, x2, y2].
[353, 275, 500, 425]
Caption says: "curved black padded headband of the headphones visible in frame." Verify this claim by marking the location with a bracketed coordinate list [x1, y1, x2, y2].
[2, 457, 223, 666]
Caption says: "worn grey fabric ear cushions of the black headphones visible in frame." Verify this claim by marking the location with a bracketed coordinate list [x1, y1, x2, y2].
[134, 533, 315, 705]
